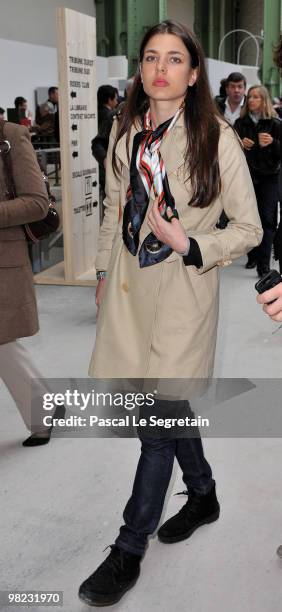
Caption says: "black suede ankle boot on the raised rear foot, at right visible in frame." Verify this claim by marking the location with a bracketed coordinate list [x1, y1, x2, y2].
[158, 485, 220, 544]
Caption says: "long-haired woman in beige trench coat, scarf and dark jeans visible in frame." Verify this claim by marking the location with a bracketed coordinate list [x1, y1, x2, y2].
[79, 21, 262, 605]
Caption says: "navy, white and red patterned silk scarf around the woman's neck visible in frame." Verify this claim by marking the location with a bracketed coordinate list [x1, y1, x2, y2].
[123, 105, 183, 268]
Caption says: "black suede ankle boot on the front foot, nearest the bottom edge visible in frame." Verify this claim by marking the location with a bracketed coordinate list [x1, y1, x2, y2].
[78, 546, 141, 606]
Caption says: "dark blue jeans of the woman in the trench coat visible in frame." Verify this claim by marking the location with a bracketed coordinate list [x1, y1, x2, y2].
[115, 434, 214, 555]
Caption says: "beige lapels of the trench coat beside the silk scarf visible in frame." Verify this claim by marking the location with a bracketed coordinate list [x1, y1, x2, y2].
[116, 113, 187, 176]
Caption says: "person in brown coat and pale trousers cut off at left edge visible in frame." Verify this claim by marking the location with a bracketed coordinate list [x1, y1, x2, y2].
[0, 122, 55, 446]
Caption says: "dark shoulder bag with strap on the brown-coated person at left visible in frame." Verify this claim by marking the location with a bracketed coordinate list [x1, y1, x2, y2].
[0, 121, 60, 243]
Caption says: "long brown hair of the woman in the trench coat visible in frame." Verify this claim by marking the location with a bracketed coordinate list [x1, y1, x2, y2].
[112, 20, 221, 208]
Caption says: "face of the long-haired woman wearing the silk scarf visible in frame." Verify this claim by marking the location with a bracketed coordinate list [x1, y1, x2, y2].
[140, 34, 197, 102]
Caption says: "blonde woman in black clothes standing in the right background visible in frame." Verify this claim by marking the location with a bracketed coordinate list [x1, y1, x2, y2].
[234, 85, 281, 276]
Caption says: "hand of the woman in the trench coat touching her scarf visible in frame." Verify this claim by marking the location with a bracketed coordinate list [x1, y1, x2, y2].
[148, 198, 189, 253]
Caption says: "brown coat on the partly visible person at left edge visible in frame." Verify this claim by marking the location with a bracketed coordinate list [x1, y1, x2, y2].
[0, 123, 49, 344]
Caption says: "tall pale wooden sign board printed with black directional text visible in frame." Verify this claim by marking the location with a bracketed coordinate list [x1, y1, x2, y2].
[57, 8, 99, 282]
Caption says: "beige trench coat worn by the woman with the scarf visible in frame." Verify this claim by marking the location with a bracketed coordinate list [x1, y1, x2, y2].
[89, 117, 262, 379]
